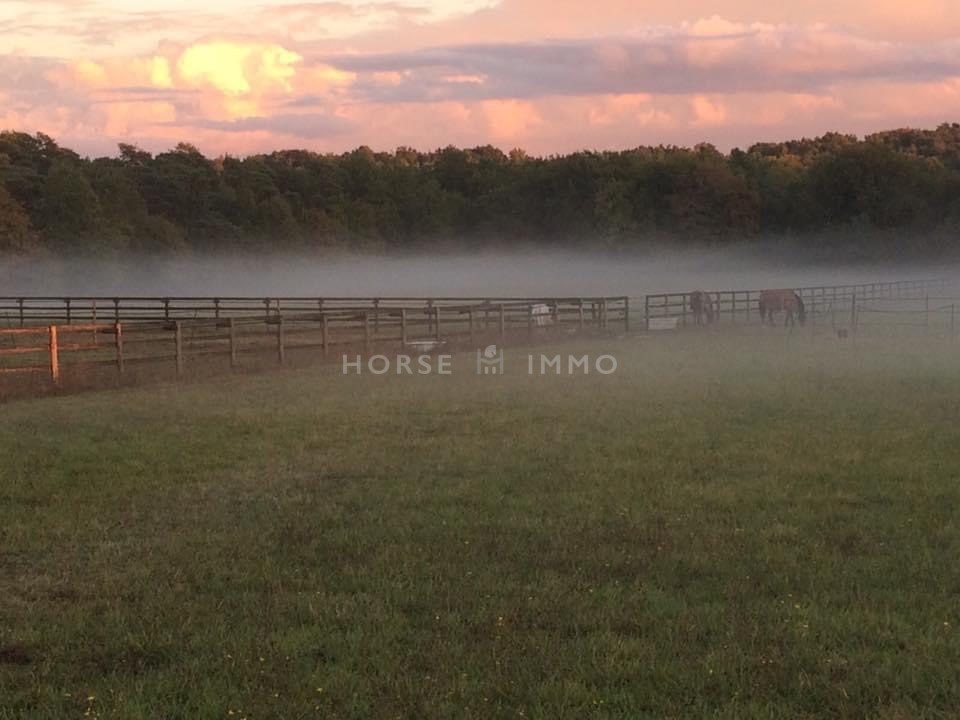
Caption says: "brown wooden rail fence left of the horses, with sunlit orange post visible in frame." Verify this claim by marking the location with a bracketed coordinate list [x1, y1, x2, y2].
[0, 297, 630, 385]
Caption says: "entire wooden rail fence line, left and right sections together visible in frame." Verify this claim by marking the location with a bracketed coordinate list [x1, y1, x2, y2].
[0, 280, 944, 396]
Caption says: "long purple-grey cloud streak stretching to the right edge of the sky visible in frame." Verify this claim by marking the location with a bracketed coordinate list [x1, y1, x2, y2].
[323, 23, 960, 102]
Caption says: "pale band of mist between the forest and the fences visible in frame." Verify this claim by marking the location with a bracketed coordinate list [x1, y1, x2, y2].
[0, 246, 954, 297]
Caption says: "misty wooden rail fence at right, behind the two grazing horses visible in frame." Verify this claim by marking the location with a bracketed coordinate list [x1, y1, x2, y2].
[643, 280, 947, 330]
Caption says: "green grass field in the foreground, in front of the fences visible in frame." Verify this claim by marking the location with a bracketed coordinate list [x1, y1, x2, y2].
[0, 330, 960, 720]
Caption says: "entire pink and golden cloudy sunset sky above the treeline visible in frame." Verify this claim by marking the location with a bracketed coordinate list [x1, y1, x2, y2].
[0, 0, 960, 155]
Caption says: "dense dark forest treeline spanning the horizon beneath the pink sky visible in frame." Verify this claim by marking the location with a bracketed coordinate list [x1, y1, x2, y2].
[0, 124, 960, 254]
